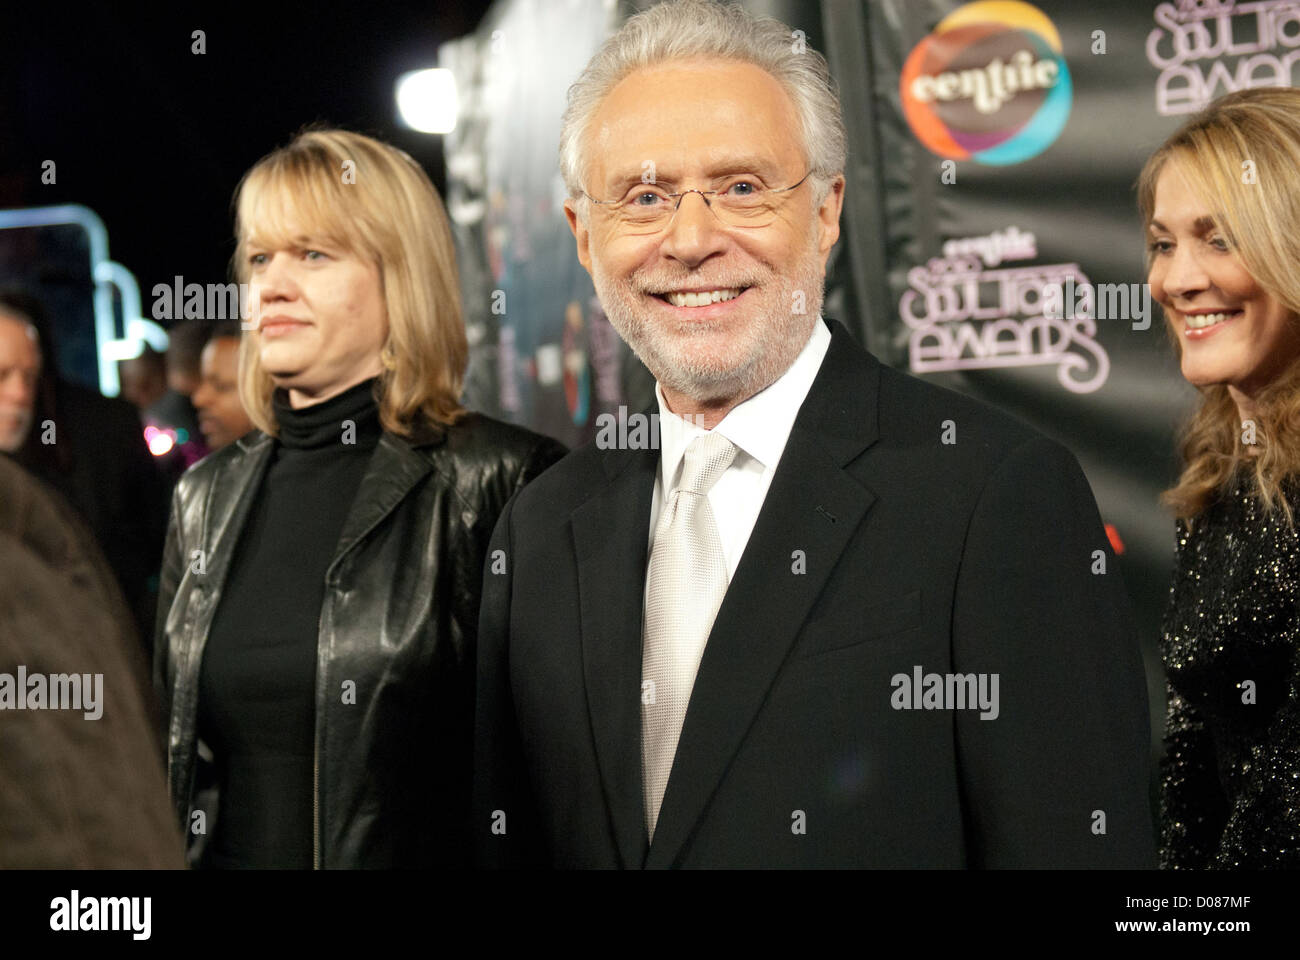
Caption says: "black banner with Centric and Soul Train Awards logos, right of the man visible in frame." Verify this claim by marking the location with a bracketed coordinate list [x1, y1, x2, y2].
[823, 0, 1300, 686]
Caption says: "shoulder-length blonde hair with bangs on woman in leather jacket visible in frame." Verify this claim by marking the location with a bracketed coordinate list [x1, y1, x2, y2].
[231, 129, 469, 436]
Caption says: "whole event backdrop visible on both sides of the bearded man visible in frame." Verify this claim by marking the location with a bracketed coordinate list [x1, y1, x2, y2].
[441, 0, 1300, 732]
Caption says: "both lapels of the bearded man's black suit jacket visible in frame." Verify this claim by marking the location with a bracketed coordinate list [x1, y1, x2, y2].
[572, 321, 880, 866]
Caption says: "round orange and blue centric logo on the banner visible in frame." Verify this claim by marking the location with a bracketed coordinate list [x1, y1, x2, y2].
[898, 0, 1074, 167]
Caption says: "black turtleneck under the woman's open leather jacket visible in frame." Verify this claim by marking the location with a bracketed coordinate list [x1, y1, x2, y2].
[199, 380, 382, 869]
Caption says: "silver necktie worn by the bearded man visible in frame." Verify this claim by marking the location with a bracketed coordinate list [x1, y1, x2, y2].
[641, 433, 738, 839]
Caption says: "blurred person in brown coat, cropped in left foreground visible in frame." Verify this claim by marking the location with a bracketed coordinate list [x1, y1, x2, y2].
[0, 455, 185, 870]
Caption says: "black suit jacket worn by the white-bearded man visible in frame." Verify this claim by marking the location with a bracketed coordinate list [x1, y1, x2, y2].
[475, 316, 1154, 868]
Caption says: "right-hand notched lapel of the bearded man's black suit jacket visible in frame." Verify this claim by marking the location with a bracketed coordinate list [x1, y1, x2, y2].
[642, 323, 879, 868]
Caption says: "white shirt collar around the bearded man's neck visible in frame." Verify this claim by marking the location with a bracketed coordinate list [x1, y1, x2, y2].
[654, 317, 831, 492]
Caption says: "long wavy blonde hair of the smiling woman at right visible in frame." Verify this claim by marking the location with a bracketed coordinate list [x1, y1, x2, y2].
[1138, 87, 1300, 527]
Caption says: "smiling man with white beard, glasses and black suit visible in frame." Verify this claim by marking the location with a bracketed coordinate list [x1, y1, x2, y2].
[473, 0, 1154, 868]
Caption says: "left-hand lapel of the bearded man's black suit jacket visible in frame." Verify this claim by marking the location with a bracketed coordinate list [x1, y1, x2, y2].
[572, 434, 659, 868]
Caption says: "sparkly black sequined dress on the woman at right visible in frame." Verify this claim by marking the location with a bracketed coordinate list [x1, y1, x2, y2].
[1160, 472, 1300, 869]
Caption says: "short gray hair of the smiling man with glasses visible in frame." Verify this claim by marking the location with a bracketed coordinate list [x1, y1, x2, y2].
[560, 0, 848, 220]
